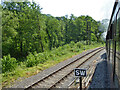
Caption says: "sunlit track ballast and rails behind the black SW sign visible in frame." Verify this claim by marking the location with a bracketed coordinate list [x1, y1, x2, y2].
[53, 47, 105, 89]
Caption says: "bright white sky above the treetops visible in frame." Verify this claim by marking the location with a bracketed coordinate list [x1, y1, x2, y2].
[29, 0, 115, 21]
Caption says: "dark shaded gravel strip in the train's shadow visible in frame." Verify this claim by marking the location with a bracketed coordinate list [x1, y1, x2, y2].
[88, 53, 114, 89]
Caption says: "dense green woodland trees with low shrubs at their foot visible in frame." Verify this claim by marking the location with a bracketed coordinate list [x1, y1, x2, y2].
[2, 2, 102, 71]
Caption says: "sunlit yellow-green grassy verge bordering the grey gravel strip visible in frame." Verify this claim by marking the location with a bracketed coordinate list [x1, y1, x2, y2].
[2, 43, 104, 87]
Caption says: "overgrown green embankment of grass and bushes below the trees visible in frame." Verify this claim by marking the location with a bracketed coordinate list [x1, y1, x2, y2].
[2, 41, 104, 86]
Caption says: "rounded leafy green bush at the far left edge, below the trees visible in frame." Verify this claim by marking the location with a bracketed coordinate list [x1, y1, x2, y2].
[2, 55, 17, 73]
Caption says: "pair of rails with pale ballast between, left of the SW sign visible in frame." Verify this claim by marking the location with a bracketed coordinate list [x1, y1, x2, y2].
[25, 47, 104, 90]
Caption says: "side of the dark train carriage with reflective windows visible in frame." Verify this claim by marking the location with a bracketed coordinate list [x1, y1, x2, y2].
[106, 0, 120, 88]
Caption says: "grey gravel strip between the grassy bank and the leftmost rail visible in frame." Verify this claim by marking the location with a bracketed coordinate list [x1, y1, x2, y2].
[11, 47, 101, 88]
